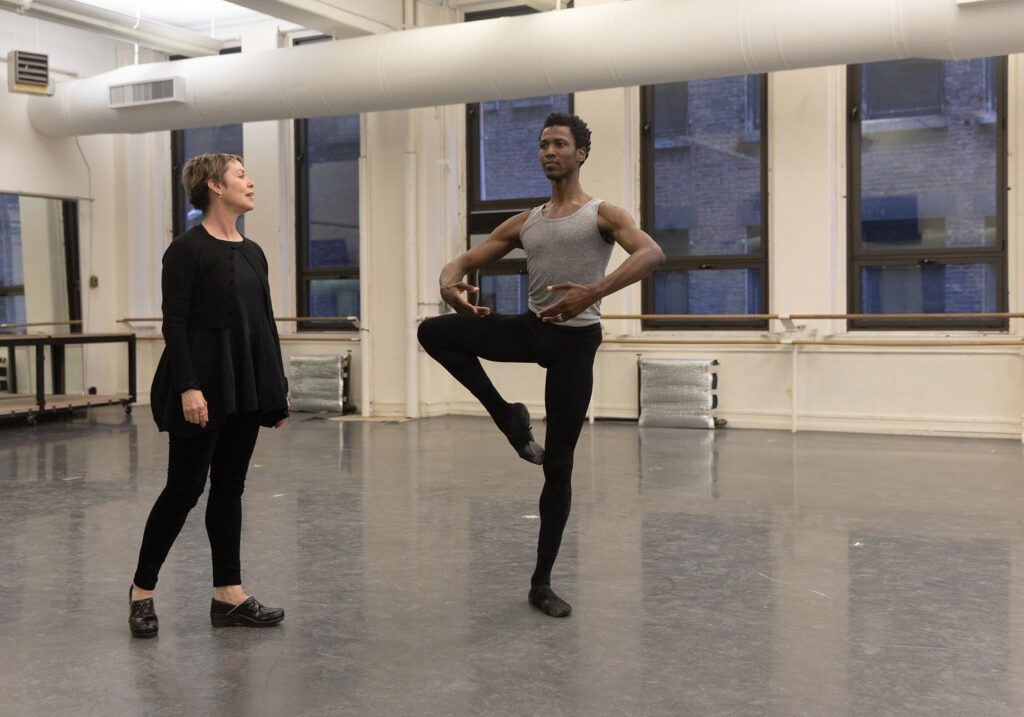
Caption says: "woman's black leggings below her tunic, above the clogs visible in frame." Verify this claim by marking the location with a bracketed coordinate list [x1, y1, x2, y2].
[134, 413, 259, 590]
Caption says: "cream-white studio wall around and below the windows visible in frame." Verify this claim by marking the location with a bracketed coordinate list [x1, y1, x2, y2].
[0, 3, 1024, 437]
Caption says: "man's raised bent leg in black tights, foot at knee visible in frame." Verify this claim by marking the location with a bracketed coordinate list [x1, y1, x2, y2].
[418, 313, 544, 463]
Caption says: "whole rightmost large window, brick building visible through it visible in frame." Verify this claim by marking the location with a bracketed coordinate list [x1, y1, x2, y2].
[848, 58, 1007, 329]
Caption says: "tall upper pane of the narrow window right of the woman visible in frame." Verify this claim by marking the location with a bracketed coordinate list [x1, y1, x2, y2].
[305, 115, 359, 268]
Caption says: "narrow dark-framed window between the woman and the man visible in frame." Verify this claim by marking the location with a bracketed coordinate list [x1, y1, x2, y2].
[295, 38, 360, 331]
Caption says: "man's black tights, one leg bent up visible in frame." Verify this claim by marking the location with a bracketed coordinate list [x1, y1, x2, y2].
[419, 312, 601, 585]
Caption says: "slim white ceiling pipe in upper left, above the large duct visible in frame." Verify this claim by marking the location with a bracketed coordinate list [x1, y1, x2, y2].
[0, 0, 224, 56]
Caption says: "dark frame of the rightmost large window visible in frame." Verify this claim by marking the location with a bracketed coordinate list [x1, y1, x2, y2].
[846, 60, 1009, 332]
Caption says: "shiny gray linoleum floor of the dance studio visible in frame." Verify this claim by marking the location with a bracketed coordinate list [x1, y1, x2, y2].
[0, 407, 1024, 717]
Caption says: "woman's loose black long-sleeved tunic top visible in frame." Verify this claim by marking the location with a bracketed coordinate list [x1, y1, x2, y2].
[151, 224, 288, 435]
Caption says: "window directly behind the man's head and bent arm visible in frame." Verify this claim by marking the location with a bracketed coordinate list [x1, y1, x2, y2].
[466, 6, 572, 313]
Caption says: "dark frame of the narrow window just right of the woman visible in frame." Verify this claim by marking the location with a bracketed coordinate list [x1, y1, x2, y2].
[293, 35, 365, 332]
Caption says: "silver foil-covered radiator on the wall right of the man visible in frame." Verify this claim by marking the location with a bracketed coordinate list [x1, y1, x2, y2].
[639, 356, 718, 428]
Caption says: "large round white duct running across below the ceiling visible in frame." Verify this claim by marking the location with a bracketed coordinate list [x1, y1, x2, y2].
[29, 0, 1024, 136]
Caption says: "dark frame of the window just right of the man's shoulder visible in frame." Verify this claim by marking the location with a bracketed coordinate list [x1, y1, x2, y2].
[640, 74, 770, 331]
